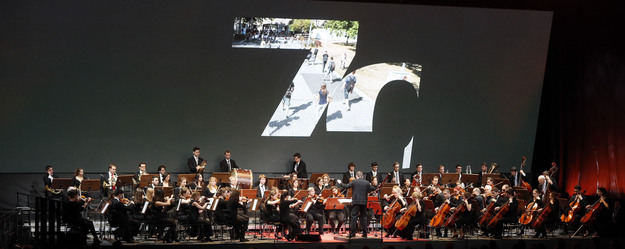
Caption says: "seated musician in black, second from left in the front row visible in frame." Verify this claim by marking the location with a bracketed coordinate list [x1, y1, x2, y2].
[109, 189, 141, 243]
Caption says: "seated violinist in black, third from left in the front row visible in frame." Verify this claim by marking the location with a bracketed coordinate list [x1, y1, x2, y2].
[151, 188, 179, 243]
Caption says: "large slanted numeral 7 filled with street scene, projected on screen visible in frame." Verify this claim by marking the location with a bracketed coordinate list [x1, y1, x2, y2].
[232, 17, 360, 137]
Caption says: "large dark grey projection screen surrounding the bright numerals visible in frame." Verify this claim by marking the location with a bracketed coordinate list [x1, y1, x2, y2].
[0, 0, 552, 179]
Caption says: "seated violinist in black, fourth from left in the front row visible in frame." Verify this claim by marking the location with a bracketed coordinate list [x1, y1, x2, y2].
[189, 192, 213, 242]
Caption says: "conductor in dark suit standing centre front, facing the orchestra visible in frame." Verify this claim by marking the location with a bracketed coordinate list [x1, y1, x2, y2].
[338, 171, 375, 238]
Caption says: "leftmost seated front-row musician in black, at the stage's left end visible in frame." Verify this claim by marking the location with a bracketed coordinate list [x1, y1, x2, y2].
[63, 187, 100, 245]
